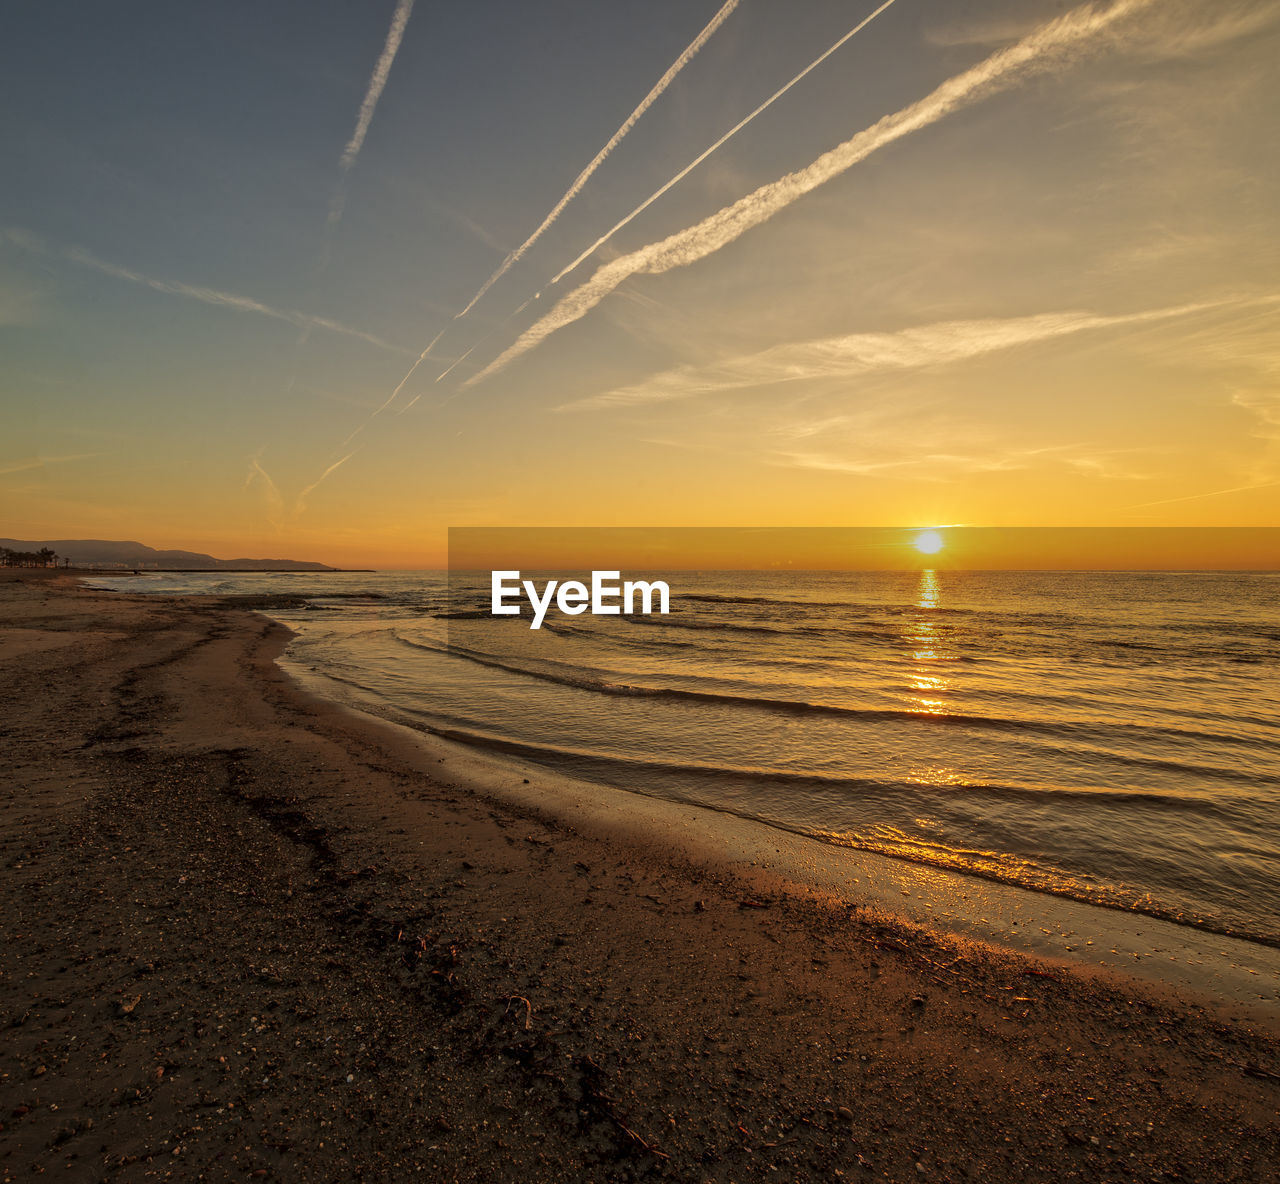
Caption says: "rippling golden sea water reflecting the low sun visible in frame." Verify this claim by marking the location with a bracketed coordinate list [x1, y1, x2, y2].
[93, 571, 1280, 946]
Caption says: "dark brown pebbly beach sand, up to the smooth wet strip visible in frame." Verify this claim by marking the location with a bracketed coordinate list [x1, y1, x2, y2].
[0, 572, 1280, 1184]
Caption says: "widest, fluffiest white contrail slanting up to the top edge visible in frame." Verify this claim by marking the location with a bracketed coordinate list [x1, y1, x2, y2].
[463, 0, 1155, 387]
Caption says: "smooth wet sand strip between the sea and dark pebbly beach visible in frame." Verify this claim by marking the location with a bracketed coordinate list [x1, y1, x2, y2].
[280, 650, 1280, 1024]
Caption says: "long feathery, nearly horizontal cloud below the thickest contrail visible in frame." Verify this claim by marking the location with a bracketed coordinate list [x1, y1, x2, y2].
[556, 301, 1224, 411]
